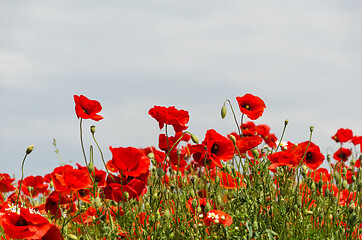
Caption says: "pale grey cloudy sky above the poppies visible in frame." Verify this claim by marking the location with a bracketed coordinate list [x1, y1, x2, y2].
[0, 0, 362, 179]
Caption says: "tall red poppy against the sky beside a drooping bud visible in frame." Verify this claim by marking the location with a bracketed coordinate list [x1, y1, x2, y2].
[236, 93, 266, 120]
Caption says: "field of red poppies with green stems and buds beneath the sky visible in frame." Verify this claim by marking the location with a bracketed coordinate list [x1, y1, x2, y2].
[0, 93, 362, 240]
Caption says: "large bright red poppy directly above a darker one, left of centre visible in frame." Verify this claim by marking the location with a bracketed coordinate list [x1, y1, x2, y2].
[109, 147, 150, 177]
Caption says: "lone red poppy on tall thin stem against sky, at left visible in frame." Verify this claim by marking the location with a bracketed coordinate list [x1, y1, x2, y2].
[74, 95, 103, 121]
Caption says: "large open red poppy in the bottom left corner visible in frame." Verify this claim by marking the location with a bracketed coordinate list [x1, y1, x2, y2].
[0, 208, 51, 239]
